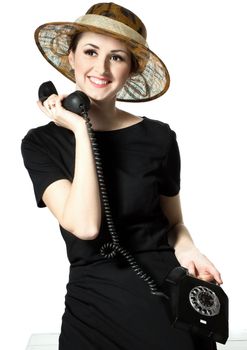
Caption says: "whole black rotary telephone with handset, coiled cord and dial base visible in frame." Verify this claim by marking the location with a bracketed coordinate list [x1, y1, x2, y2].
[38, 81, 228, 344]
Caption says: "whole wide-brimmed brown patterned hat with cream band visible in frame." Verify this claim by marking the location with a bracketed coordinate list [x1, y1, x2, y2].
[35, 2, 170, 102]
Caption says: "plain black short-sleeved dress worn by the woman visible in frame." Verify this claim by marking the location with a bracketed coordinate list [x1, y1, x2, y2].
[22, 117, 215, 350]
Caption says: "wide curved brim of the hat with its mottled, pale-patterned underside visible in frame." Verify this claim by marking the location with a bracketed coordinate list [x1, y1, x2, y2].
[34, 22, 170, 102]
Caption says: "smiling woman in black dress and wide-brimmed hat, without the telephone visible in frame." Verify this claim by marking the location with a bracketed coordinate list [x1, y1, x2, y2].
[22, 3, 222, 350]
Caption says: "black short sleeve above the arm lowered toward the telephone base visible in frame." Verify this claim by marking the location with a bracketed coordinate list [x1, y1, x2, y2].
[160, 132, 181, 197]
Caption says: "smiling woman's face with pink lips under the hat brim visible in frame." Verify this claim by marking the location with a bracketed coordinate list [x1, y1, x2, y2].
[69, 32, 131, 101]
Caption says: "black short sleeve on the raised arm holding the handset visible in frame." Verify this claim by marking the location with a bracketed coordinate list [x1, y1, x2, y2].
[21, 134, 67, 208]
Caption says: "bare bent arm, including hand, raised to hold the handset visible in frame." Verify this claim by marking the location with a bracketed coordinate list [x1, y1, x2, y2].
[39, 93, 101, 240]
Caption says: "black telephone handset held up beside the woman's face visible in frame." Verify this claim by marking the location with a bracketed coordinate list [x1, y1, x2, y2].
[38, 81, 90, 116]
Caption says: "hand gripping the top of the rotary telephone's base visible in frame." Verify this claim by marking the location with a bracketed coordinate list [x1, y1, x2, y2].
[175, 247, 223, 284]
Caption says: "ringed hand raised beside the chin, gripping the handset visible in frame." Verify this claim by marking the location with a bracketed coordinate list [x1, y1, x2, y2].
[37, 94, 86, 133]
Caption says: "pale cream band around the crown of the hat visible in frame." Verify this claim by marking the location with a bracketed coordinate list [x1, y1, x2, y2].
[75, 15, 148, 47]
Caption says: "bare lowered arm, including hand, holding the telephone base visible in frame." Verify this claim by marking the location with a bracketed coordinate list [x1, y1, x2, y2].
[160, 195, 223, 284]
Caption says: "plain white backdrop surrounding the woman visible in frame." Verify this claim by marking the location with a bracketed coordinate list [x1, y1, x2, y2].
[0, 0, 247, 350]
